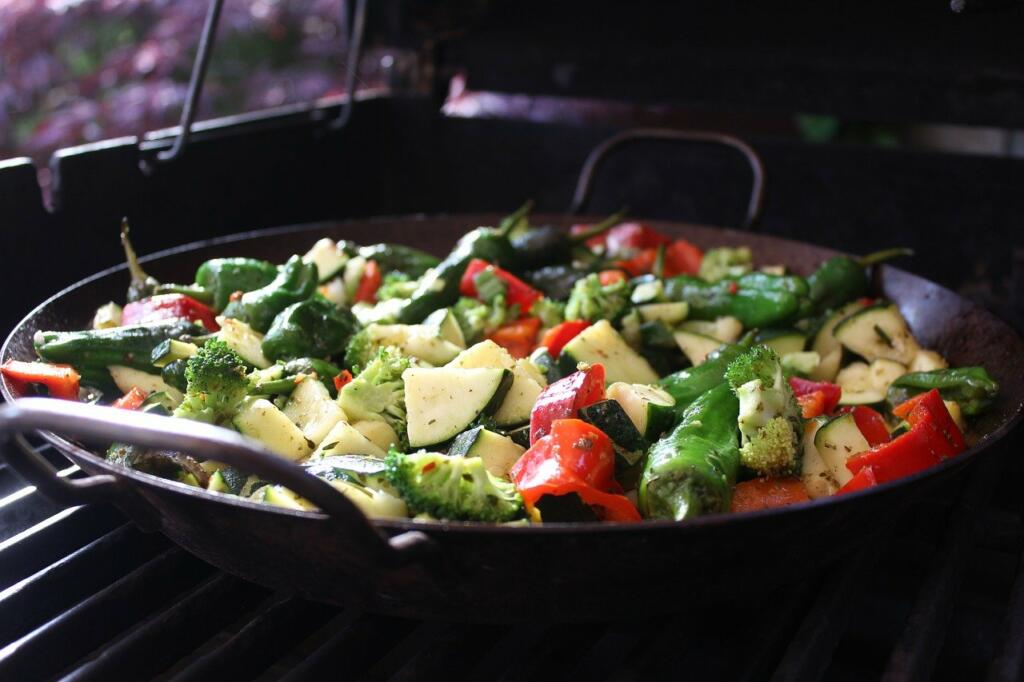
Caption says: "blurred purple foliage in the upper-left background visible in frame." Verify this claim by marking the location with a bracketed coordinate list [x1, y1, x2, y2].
[0, 0, 344, 166]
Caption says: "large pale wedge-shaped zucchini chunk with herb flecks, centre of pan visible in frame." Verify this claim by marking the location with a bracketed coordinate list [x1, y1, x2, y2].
[401, 367, 512, 447]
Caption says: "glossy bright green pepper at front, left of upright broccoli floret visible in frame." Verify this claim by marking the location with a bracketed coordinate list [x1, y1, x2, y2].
[638, 383, 739, 521]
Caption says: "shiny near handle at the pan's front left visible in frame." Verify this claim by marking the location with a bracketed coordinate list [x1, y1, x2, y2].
[0, 398, 434, 565]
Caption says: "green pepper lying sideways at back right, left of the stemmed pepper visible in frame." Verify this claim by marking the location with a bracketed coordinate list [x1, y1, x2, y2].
[665, 272, 809, 328]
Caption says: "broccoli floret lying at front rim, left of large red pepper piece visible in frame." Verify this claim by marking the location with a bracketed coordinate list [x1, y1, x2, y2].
[385, 451, 525, 522]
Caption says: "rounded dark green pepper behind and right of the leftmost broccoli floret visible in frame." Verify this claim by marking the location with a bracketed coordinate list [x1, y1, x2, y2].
[263, 296, 358, 360]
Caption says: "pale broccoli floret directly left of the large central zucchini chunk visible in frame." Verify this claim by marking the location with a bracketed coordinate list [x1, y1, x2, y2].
[338, 346, 411, 441]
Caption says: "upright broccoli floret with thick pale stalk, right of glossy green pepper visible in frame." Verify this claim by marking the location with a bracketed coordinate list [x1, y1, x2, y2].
[725, 346, 804, 476]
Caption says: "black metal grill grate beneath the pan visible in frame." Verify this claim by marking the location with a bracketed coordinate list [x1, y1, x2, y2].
[0, 432, 1024, 682]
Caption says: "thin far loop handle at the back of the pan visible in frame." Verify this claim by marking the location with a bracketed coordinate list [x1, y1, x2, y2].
[569, 128, 765, 229]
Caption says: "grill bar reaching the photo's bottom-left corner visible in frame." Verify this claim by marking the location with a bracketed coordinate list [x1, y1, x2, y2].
[0, 548, 213, 680]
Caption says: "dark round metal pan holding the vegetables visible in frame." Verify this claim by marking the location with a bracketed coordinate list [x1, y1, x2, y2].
[0, 216, 1024, 623]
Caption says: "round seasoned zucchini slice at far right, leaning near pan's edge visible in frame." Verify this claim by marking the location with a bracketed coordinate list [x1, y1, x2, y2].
[836, 303, 921, 365]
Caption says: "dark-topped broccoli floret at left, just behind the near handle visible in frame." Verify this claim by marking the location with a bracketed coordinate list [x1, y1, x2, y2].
[174, 339, 252, 424]
